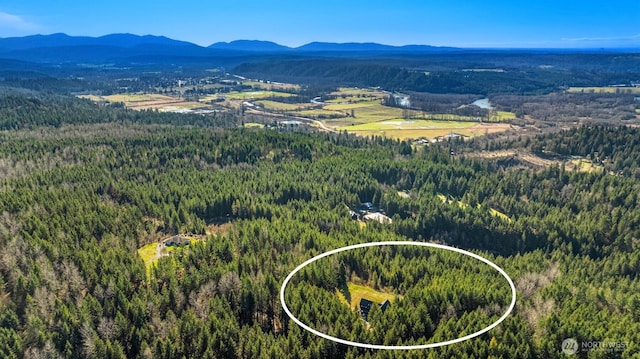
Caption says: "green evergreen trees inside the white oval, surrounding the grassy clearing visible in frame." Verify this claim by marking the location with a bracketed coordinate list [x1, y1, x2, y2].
[285, 246, 516, 348]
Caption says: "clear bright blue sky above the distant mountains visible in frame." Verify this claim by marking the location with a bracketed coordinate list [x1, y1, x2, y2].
[0, 0, 640, 48]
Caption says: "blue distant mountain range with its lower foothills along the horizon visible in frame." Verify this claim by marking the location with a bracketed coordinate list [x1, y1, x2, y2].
[0, 34, 632, 71]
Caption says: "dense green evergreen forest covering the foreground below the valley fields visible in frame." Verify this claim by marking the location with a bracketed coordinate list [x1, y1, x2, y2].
[0, 93, 640, 358]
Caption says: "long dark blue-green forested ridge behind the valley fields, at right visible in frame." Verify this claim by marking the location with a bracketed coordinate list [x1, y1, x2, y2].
[233, 54, 640, 96]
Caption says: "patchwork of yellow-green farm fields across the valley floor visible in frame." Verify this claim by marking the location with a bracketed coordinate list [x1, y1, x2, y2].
[81, 86, 515, 140]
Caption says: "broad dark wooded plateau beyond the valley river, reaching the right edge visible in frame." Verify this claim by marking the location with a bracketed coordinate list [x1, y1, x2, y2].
[234, 51, 640, 95]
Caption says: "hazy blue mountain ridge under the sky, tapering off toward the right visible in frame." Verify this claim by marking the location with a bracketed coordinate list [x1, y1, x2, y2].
[0, 34, 460, 63]
